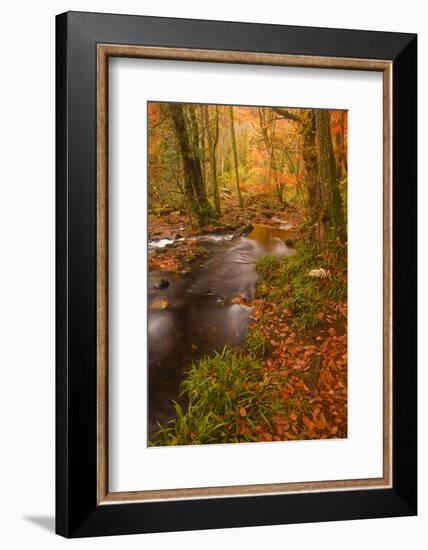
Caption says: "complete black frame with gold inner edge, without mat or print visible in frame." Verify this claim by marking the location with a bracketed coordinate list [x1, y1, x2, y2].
[56, 12, 417, 537]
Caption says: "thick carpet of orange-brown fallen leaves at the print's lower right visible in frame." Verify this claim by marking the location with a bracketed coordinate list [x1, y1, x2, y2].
[247, 280, 348, 441]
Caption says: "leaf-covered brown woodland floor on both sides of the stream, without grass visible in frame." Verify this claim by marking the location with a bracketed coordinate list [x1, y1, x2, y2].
[149, 196, 347, 444]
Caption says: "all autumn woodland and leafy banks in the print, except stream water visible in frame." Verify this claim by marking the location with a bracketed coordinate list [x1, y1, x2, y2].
[148, 102, 348, 445]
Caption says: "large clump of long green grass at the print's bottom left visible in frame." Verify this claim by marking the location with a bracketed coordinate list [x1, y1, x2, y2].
[151, 347, 290, 446]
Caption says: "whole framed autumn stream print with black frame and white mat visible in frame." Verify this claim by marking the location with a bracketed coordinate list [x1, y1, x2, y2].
[56, 12, 417, 537]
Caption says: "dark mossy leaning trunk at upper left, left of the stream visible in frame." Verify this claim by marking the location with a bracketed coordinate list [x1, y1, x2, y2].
[168, 103, 215, 226]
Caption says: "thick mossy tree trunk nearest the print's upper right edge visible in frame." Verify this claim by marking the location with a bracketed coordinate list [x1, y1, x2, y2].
[315, 109, 346, 241]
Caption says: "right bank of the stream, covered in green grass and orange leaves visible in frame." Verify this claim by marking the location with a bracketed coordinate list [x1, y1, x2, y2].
[152, 205, 347, 445]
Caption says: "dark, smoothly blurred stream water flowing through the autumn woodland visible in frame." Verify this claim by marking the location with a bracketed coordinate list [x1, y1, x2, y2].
[148, 225, 293, 439]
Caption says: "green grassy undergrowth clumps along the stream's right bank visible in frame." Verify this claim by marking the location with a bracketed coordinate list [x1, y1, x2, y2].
[150, 242, 347, 446]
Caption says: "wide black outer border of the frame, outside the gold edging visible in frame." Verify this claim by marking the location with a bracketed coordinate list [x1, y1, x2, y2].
[56, 12, 417, 537]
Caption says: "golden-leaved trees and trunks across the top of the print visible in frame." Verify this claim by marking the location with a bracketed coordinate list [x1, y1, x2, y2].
[149, 103, 347, 243]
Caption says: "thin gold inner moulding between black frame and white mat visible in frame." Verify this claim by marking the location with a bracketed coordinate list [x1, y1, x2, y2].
[97, 44, 392, 505]
